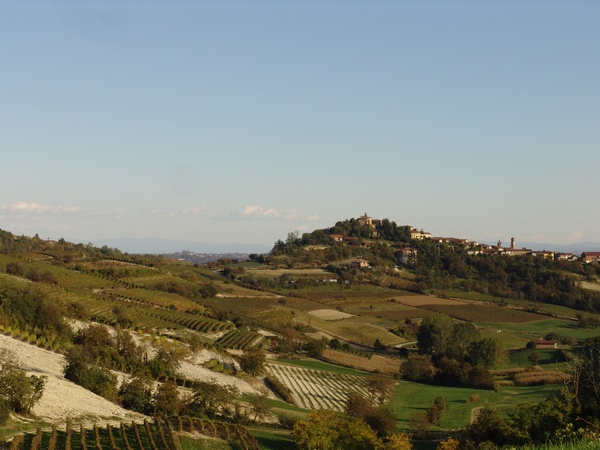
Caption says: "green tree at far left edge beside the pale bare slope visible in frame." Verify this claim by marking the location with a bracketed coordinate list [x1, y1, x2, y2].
[0, 349, 46, 425]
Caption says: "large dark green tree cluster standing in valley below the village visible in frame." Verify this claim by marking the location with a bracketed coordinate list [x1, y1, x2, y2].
[402, 314, 504, 389]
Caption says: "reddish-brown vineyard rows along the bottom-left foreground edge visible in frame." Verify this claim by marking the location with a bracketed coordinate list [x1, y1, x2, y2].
[10, 417, 259, 450]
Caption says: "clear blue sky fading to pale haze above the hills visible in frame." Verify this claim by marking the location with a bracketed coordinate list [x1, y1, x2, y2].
[0, 0, 600, 250]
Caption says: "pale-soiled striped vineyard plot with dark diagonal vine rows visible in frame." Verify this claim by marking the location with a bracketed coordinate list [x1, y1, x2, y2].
[267, 363, 368, 411]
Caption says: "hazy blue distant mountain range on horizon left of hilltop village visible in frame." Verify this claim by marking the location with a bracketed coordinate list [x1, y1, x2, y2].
[92, 238, 272, 255]
